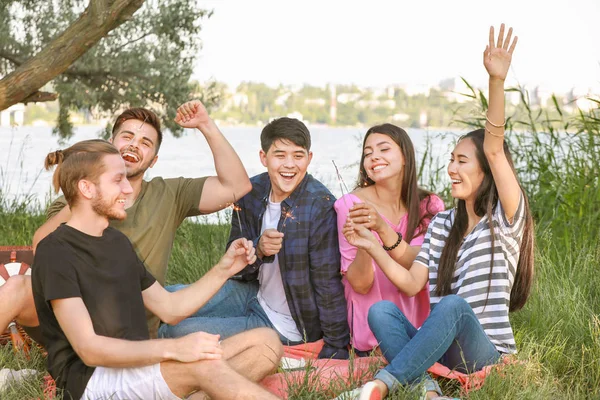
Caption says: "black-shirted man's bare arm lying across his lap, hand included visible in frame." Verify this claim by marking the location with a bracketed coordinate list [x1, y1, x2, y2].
[50, 297, 222, 368]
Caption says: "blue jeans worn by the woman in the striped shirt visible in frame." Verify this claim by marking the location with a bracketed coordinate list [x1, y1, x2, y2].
[369, 295, 500, 392]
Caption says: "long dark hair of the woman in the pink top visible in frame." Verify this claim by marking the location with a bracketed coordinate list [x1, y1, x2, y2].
[356, 124, 433, 243]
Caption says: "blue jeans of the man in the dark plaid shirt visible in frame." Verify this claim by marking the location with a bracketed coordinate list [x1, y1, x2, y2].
[158, 280, 281, 339]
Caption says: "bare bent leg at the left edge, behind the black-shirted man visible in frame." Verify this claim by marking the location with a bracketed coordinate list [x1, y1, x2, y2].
[0, 275, 40, 332]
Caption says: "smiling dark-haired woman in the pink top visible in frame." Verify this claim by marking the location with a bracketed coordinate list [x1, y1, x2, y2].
[335, 124, 444, 355]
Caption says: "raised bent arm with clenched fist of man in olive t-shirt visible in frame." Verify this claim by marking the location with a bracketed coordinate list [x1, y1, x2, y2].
[175, 100, 252, 214]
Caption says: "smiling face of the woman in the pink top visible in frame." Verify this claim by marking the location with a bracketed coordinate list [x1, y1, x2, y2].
[363, 133, 405, 183]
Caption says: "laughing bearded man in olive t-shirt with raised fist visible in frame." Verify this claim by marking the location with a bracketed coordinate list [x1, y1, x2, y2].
[0, 101, 252, 338]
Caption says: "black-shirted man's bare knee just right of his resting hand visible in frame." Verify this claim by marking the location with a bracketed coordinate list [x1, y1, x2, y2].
[221, 328, 283, 382]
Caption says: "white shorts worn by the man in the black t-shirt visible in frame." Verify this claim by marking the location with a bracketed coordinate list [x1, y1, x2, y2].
[81, 364, 181, 400]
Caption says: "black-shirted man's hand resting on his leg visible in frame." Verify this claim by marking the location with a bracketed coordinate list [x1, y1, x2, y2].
[168, 332, 223, 362]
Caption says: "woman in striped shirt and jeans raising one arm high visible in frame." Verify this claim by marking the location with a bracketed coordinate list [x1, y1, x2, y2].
[343, 24, 533, 400]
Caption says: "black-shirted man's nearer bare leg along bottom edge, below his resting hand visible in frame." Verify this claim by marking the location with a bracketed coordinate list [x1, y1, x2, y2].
[160, 360, 277, 400]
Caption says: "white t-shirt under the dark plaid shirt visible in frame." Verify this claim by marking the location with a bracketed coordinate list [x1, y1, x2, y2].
[257, 199, 302, 342]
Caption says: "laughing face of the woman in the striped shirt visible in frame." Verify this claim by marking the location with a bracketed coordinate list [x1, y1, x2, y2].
[448, 138, 485, 201]
